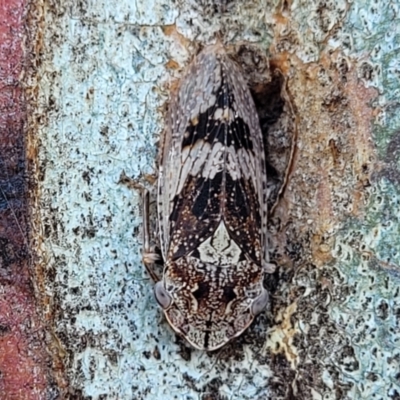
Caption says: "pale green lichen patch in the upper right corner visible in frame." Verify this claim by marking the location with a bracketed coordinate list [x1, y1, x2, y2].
[344, 0, 400, 158]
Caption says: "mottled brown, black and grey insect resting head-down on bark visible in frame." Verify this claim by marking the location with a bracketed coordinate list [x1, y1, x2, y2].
[144, 44, 273, 351]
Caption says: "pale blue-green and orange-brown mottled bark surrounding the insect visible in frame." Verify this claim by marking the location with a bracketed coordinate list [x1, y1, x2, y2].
[26, 0, 400, 399]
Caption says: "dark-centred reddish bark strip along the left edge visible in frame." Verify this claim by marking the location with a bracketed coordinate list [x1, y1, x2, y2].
[0, 0, 48, 400]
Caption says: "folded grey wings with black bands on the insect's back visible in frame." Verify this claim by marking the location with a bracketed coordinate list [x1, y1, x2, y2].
[159, 45, 267, 259]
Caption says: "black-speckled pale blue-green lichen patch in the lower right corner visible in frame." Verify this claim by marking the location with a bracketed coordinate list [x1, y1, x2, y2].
[329, 179, 400, 399]
